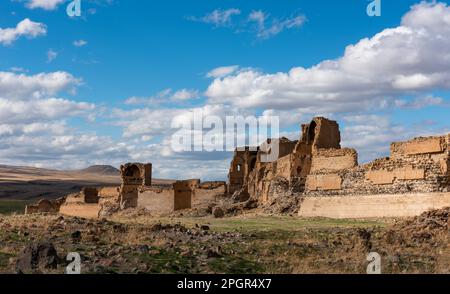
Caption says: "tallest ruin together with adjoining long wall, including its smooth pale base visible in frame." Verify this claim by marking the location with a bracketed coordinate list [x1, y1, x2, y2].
[228, 117, 450, 217]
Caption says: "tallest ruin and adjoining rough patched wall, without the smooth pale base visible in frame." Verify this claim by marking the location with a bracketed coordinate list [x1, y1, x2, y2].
[229, 117, 450, 214]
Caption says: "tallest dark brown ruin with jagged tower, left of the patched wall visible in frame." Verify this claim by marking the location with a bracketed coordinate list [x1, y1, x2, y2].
[228, 117, 341, 203]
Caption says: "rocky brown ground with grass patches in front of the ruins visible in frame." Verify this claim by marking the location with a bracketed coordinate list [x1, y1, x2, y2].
[0, 209, 450, 273]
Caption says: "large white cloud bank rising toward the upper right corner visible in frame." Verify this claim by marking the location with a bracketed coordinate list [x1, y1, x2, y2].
[206, 3, 450, 113]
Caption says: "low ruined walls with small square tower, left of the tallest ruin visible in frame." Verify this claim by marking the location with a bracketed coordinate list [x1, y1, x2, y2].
[25, 163, 226, 218]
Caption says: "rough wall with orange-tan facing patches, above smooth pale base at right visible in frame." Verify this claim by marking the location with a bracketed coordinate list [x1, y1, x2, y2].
[305, 136, 449, 196]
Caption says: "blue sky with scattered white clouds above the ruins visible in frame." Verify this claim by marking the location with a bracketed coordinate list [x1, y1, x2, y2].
[0, 0, 450, 179]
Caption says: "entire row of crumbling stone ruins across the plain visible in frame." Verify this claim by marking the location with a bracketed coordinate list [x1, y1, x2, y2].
[26, 117, 450, 218]
